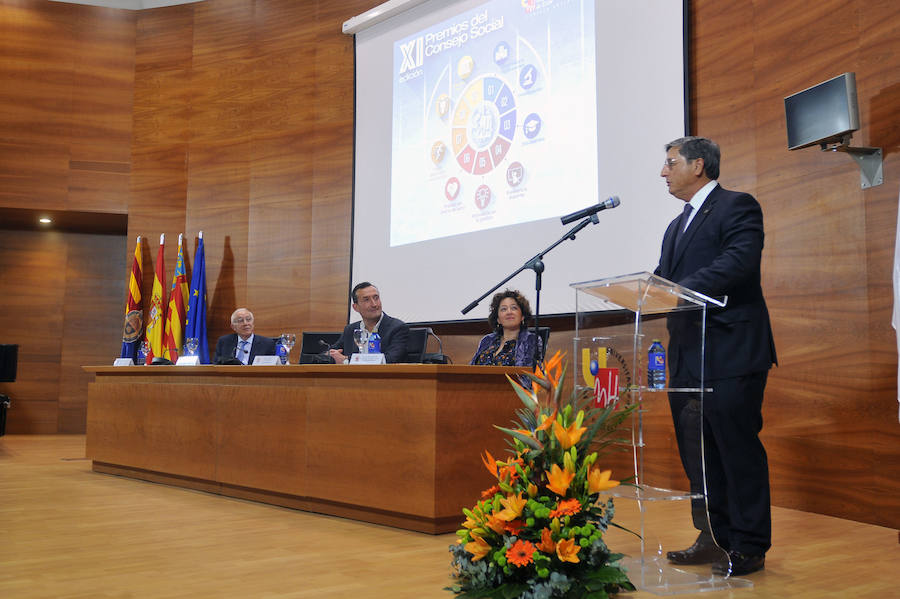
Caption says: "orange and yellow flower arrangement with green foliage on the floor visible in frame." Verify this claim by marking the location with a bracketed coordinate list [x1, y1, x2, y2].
[447, 352, 634, 599]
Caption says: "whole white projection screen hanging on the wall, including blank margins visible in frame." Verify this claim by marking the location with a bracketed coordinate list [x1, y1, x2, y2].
[351, 0, 686, 323]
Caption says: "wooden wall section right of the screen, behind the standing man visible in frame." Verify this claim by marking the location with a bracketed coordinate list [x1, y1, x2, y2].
[691, 0, 900, 526]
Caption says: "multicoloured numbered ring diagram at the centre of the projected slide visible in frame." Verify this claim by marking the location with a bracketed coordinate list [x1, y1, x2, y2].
[452, 75, 516, 175]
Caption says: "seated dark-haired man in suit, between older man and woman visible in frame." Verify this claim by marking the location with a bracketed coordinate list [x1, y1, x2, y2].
[328, 281, 409, 364]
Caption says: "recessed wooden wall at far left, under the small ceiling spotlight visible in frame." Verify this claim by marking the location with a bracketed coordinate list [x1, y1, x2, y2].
[0, 230, 125, 433]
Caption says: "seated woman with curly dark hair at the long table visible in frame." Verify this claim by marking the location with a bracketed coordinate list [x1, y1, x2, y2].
[470, 289, 542, 366]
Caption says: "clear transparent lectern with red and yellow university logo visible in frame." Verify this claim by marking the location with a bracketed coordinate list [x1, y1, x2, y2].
[571, 272, 752, 595]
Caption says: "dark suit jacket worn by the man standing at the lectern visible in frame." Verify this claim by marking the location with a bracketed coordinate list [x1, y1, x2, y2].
[655, 186, 777, 381]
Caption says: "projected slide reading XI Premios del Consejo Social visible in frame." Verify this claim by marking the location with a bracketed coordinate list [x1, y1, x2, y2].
[388, 0, 597, 247]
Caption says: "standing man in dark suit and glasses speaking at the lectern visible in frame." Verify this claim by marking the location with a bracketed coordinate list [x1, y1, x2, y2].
[656, 137, 777, 575]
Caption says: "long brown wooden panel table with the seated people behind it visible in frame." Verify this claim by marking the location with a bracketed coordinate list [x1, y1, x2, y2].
[84, 364, 522, 534]
